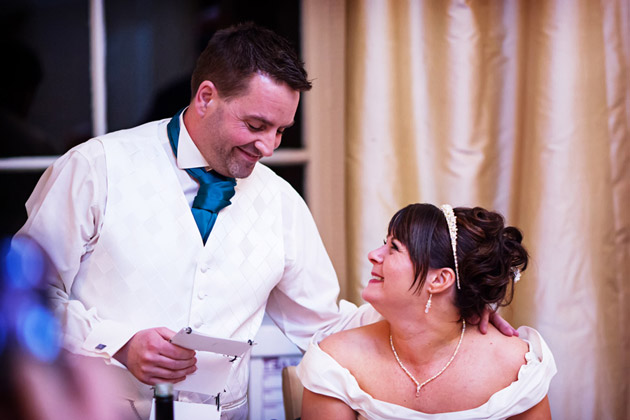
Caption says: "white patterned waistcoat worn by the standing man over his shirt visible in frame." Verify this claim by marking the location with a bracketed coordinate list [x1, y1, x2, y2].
[72, 123, 290, 410]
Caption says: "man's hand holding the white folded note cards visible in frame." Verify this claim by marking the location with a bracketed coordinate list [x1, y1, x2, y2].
[114, 327, 197, 385]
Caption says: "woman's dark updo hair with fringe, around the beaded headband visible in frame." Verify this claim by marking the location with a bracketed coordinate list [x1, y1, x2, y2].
[387, 204, 529, 319]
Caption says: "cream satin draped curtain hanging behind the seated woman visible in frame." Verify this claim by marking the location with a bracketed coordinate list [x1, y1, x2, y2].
[345, 0, 630, 419]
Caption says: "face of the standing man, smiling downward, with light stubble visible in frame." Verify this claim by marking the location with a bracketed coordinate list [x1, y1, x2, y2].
[195, 74, 300, 178]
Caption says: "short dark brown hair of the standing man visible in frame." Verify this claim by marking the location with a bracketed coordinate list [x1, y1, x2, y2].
[191, 23, 311, 98]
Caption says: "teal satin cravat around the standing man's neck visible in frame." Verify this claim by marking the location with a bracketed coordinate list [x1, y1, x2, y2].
[167, 109, 236, 244]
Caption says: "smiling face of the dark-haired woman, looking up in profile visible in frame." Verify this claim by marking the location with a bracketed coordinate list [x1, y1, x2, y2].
[362, 236, 415, 306]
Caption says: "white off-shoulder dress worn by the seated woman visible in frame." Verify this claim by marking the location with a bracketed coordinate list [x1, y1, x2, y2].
[297, 327, 556, 420]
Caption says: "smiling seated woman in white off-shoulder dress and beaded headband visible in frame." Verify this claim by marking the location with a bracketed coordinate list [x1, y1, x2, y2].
[297, 204, 556, 420]
